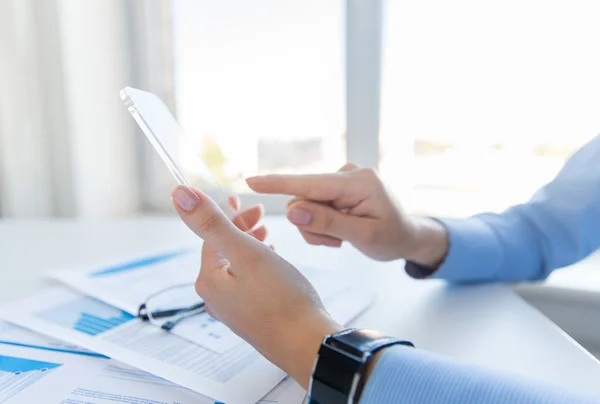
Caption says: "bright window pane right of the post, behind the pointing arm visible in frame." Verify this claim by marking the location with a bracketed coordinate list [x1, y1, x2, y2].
[380, 0, 600, 216]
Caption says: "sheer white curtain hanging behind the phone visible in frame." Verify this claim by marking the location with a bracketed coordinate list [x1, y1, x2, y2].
[0, 0, 174, 218]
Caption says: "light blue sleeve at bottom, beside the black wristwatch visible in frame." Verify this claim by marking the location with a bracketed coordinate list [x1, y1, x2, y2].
[360, 346, 600, 404]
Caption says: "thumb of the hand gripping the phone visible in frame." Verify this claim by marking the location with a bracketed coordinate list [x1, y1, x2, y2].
[171, 185, 248, 257]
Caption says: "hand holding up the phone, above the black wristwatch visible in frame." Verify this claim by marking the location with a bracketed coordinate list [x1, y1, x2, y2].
[171, 186, 342, 388]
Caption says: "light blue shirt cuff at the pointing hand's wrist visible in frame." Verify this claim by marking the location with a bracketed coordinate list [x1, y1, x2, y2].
[405, 217, 502, 283]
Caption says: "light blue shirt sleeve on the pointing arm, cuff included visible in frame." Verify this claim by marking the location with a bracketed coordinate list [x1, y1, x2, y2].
[426, 136, 600, 282]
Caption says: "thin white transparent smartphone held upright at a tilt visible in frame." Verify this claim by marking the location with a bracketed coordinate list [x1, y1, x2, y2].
[120, 87, 235, 218]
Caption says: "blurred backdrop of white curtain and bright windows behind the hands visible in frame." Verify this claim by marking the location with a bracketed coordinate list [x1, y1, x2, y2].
[0, 0, 600, 219]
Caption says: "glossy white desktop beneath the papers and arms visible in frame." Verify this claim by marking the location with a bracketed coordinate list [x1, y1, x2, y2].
[0, 218, 600, 393]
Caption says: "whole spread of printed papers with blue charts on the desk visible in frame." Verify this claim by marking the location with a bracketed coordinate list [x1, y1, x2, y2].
[0, 250, 373, 404]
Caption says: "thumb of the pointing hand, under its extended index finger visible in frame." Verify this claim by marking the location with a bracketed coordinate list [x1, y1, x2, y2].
[287, 200, 369, 243]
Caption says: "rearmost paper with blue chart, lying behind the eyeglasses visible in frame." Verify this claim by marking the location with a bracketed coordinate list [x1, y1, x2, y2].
[50, 248, 360, 353]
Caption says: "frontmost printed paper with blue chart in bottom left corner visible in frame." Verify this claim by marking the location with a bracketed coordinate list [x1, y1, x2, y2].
[0, 322, 305, 404]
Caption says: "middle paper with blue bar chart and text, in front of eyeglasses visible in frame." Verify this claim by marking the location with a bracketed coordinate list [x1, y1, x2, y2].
[0, 286, 370, 404]
